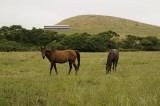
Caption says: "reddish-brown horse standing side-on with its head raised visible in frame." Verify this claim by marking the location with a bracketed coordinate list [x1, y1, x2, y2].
[41, 47, 80, 75]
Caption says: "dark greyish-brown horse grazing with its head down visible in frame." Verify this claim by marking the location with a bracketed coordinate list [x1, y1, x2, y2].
[106, 49, 119, 74]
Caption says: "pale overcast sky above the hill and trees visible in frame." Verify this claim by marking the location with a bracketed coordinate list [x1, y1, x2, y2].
[0, 0, 160, 29]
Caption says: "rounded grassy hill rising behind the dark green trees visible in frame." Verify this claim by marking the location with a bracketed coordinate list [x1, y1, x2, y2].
[58, 15, 160, 37]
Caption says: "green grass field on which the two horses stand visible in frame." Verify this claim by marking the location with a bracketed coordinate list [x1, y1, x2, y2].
[0, 52, 160, 106]
